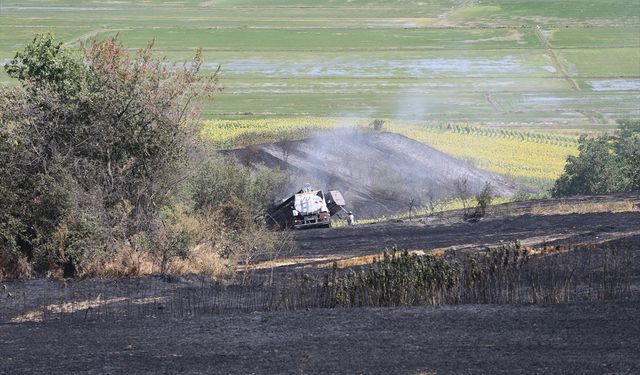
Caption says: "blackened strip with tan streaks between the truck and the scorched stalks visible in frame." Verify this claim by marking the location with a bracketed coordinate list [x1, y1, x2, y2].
[282, 194, 640, 266]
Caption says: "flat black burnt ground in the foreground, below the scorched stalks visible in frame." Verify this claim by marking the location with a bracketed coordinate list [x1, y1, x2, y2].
[0, 301, 640, 374]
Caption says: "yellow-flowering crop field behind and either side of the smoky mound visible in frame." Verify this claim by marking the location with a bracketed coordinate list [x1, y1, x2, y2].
[203, 117, 577, 188]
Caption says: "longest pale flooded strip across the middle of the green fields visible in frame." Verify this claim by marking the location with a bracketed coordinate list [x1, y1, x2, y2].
[206, 56, 546, 78]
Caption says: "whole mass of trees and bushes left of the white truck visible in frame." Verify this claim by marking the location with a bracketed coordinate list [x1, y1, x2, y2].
[0, 34, 280, 278]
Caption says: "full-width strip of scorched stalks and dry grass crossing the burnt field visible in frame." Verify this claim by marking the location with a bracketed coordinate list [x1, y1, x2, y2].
[0, 242, 638, 321]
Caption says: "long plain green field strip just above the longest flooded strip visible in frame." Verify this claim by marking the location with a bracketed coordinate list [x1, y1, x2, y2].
[98, 28, 541, 52]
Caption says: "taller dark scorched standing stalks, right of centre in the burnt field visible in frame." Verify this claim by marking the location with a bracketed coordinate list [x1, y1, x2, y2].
[270, 242, 637, 309]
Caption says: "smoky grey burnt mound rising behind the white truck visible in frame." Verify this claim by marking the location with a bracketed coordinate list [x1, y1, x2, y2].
[228, 131, 515, 218]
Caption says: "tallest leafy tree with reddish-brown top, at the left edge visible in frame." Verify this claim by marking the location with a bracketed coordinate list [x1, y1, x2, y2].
[0, 34, 217, 276]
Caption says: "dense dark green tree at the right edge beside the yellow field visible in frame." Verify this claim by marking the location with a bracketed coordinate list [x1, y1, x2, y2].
[552, 120, 640, 197]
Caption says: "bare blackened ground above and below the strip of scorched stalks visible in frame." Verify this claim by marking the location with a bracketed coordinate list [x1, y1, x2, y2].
[0, 193, 640, 374]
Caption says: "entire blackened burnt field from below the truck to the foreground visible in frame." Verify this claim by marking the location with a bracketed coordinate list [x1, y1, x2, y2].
[0, 194, 640, 374]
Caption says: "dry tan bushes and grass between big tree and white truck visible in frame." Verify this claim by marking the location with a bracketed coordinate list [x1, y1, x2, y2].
[81, 199, 291, 281]
